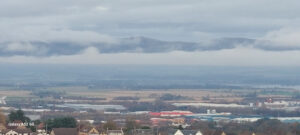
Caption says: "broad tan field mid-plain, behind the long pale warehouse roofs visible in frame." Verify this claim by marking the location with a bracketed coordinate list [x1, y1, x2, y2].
[67, 90, 248, 102]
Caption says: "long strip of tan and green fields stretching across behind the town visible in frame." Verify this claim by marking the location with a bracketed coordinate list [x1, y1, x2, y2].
[0, 87, 296, 102]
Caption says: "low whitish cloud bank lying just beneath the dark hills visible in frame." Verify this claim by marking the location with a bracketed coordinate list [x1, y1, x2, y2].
[0, 47, 300, 67]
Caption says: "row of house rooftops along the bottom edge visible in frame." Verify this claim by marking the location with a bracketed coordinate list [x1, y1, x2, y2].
[0, 124, 255, 135]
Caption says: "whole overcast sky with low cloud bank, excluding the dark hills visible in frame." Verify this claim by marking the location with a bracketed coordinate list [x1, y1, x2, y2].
[0, 0, 300, 66]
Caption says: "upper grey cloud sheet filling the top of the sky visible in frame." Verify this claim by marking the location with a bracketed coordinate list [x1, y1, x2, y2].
[0, 0, 300, 41]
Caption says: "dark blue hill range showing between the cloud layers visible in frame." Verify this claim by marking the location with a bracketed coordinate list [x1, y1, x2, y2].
[0, 37, 256, 56]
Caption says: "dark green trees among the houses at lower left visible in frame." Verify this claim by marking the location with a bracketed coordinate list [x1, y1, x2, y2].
[0, 110, 146, 134]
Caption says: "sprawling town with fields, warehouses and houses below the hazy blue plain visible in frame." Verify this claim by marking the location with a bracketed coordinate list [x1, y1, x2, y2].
[0, 87, 300, 135]
